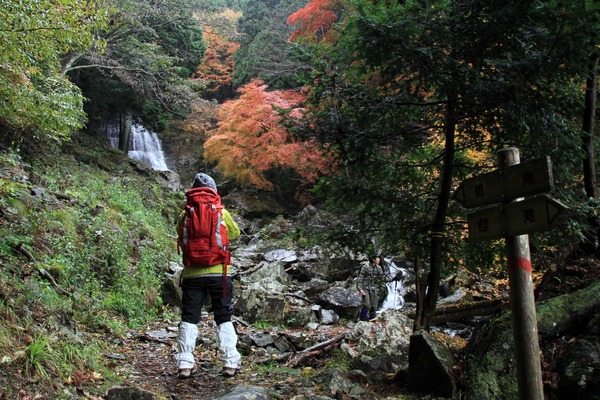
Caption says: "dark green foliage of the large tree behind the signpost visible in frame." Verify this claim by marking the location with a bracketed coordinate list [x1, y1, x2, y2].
[304, 0, 597, 273]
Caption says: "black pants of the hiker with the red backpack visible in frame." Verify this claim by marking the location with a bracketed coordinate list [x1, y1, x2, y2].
[181, 276, 233, 325]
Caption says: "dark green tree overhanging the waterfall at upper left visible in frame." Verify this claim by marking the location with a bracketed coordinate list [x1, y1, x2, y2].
[63, 0, 205, 133]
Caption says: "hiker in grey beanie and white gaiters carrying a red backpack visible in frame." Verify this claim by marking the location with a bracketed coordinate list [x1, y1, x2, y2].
[176, 173, 241, 379]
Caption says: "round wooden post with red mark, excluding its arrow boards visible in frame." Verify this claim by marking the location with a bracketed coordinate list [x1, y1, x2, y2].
[498, 148, 544, 400]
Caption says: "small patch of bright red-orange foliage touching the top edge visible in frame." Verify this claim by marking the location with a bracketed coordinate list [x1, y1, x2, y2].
[287, 0, 338, 42]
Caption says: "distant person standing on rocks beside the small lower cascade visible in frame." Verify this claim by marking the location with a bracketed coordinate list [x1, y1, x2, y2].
[355, 256, 401, 321]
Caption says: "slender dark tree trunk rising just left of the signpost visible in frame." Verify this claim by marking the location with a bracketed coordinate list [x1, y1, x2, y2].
[415, 88, 457, 329]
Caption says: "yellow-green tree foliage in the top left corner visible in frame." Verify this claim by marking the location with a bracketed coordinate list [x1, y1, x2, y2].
[0, 0, 106, 143]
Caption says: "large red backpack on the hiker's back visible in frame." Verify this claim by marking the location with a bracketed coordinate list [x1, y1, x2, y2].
[177, 187, 231, 267]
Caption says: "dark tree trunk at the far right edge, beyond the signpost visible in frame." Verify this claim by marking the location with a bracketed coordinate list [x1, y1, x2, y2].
[582, 54, 600, 251]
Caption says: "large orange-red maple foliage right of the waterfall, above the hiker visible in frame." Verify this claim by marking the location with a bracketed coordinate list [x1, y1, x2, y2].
[204, 80, 332, 189]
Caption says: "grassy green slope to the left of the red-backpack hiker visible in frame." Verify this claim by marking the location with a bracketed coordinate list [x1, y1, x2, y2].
[0, 137, 180, 398]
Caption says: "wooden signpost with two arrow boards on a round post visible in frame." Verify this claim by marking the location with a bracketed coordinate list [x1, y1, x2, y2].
[454, 148, 567, 400]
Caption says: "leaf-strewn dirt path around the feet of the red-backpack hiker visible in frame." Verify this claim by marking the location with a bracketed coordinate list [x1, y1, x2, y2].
[108, 318, 408, 400]
